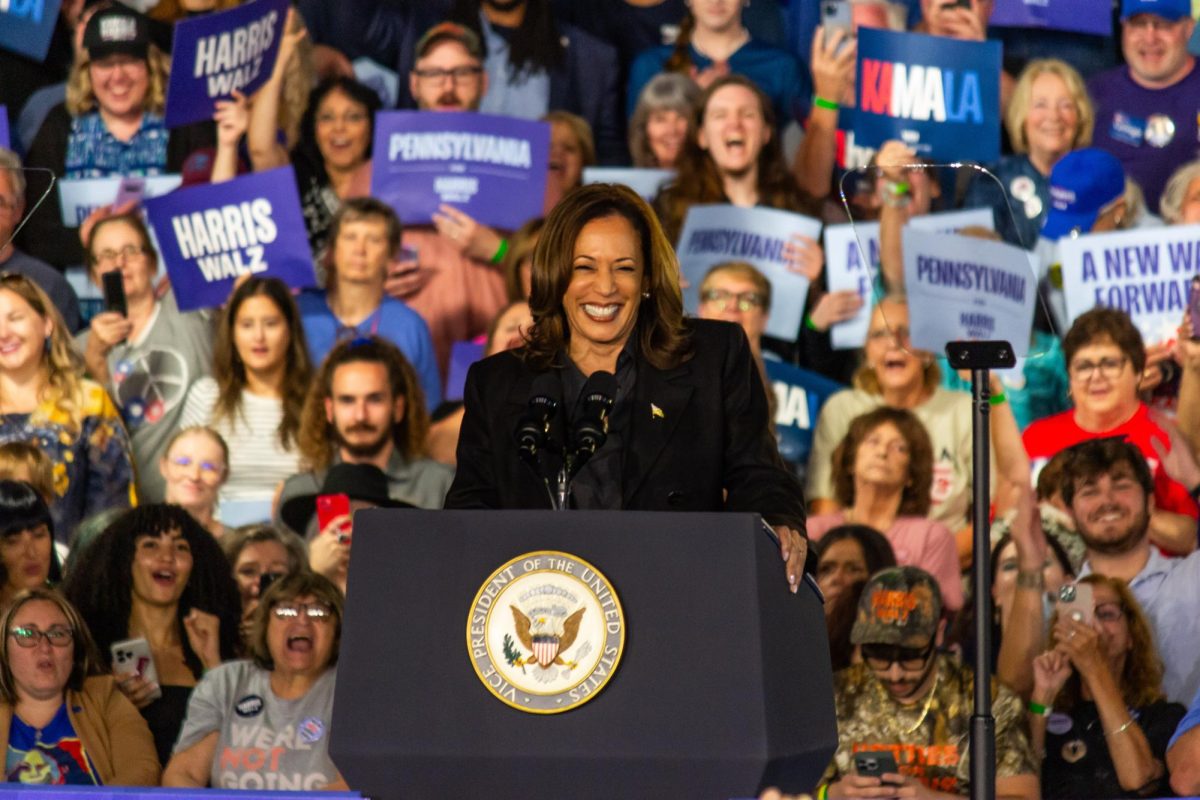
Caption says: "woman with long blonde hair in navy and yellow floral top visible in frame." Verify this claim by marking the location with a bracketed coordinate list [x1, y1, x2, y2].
[0, 273, 133, 543]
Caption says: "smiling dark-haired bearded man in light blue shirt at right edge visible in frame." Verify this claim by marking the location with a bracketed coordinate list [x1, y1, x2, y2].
[1062, 437, 1200, 703]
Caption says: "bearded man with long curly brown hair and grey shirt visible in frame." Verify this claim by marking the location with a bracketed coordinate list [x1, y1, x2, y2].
[280, 337, 454, 536]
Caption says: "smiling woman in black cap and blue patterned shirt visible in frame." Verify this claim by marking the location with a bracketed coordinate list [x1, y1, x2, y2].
[22, 2, 215, 269]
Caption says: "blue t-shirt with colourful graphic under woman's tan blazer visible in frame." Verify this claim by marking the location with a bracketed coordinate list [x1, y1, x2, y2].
[4, 703, 102, 786]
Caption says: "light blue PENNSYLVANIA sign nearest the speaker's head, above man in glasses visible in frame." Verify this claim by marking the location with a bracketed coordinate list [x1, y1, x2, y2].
[676, 205, 821, 342]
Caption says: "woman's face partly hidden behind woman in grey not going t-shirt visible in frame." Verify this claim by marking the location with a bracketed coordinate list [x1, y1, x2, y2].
[221, 525, 308, 648]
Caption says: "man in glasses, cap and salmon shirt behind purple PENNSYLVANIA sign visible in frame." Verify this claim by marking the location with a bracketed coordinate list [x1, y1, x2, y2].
[386, 23, 506, 378]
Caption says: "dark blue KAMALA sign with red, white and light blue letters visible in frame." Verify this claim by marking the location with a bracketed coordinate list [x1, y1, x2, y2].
[854, 28, 1000, 163]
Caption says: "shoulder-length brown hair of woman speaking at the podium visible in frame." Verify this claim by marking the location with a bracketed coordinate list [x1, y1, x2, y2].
[522, 184, 691, 369]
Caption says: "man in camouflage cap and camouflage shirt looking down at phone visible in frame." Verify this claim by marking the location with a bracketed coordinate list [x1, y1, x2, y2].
[817, 566, 1038, 800]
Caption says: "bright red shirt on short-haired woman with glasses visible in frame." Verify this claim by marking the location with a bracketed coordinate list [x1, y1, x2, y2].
[1021, 403, 1200, 519]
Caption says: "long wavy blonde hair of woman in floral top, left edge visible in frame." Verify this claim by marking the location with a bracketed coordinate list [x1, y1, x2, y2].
[0, 272, 83, 434]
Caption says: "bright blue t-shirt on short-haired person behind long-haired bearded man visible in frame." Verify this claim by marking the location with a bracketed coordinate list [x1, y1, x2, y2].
[296, 290, 442, 410]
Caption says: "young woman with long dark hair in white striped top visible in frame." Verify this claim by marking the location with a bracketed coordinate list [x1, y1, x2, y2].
[181, 277, 312, 519]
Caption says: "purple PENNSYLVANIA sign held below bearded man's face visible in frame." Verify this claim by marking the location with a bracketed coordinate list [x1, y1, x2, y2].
[371, 112, 550, 230]
